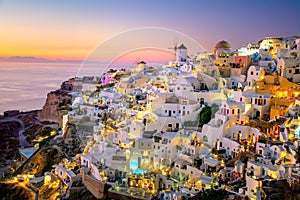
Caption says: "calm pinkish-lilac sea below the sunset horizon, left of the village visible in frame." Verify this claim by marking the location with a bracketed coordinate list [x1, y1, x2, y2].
[0, 62, 80, 115]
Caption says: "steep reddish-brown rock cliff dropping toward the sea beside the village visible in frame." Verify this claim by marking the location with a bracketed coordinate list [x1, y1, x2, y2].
[38, 90, 71, 123]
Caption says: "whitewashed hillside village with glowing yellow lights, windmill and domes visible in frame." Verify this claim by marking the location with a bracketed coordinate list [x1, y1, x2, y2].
[4, 37, 300, 200]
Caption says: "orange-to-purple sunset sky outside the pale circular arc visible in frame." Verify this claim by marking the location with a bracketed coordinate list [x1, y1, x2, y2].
[0, 0, 300, 59]
